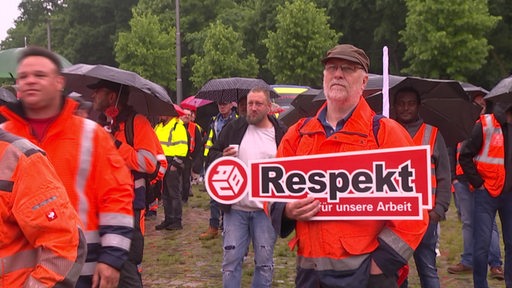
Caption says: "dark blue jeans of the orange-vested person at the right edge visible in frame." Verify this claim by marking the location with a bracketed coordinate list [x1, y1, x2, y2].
[473, 189, 512, 288]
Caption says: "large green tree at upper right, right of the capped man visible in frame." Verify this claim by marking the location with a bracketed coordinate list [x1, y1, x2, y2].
[400, 0, 500, 81]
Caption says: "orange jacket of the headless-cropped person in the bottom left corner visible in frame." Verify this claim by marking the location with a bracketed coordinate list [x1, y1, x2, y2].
[0, 130, 86, 288]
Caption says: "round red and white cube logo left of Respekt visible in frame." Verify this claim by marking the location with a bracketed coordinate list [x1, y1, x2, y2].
[205, 157, 249, 204]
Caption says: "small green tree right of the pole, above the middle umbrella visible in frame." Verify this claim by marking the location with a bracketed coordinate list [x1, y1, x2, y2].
[191, 21, 259, 88]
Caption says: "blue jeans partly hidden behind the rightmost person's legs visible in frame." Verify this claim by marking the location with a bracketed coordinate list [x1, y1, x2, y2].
[453, 182, 503, 267]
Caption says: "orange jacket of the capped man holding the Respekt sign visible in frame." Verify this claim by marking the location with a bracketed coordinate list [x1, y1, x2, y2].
[267, 97, 429, 279]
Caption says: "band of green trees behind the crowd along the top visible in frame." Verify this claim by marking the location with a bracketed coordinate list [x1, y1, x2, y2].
[0, 0, 512, 95]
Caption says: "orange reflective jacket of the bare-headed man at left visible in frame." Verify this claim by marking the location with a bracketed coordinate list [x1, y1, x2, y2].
[0, 99, 133, 276]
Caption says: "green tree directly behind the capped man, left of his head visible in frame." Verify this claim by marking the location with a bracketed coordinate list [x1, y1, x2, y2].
[264, 0, 341, 86]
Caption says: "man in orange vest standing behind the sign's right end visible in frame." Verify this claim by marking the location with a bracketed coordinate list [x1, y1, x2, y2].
[393, 87, 451, 288]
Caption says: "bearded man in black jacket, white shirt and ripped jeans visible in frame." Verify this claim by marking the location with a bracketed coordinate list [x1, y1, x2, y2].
[210, 88, 286, 287]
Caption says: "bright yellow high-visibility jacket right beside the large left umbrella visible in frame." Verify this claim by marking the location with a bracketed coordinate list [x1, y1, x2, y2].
[155, 117, 188, 157]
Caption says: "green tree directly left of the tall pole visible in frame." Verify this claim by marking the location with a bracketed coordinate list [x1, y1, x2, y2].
[115, 9, 176, 90]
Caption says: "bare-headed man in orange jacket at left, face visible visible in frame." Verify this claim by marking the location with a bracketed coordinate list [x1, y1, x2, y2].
[0, 47, 133, 287]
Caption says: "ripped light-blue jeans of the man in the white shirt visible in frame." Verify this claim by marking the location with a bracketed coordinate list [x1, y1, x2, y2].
[222, 209, 277, 288]
